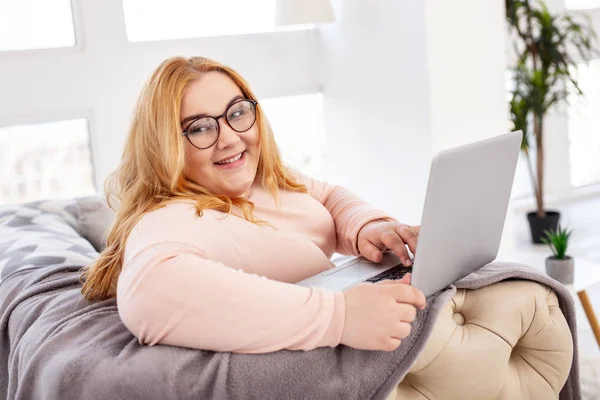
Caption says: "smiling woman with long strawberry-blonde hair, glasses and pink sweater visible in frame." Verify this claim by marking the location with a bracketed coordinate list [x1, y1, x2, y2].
[82, 57, 425, 353]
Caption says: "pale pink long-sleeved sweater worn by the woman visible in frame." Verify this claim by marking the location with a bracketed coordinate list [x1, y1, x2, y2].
[117, 176, 389, 353]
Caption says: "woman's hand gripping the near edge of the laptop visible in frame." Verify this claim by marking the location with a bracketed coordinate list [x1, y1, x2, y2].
[341, 274, 426, 351]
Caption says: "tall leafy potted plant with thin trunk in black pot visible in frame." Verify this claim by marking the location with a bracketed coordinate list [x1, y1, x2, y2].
[506, 0, 597, 243]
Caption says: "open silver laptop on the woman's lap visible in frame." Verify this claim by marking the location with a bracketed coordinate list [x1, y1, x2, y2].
[297, 131, 523, 296]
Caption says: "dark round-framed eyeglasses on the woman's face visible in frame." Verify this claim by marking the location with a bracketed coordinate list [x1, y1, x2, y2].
[183, 100, 258, 150]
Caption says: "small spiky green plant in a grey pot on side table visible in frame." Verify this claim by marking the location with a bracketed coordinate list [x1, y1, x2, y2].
[542, 225, 574, 285]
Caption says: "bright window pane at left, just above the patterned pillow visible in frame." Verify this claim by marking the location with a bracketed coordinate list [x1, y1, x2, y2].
[0, 119, 96, 204]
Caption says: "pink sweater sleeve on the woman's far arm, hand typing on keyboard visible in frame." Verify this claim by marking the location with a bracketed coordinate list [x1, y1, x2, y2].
[293, 171, 397, 256]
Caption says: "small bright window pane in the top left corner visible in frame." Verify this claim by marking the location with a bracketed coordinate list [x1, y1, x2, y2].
[0, 0, 75, 51]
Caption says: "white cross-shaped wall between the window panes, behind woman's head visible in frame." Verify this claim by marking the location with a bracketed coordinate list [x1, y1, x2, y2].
[0, 0, 319, 190]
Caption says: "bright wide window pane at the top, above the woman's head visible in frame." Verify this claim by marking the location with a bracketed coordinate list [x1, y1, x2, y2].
[123, 0, 276, 42]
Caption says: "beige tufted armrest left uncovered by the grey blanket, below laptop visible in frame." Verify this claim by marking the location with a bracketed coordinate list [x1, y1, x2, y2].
[388, 280, 573, 400]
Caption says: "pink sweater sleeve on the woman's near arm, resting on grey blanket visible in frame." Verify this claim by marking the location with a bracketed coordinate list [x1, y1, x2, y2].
[117, 242, 345, 353]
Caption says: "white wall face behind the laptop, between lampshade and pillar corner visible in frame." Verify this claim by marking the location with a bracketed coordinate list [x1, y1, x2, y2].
[320, 0, 432, 223]
